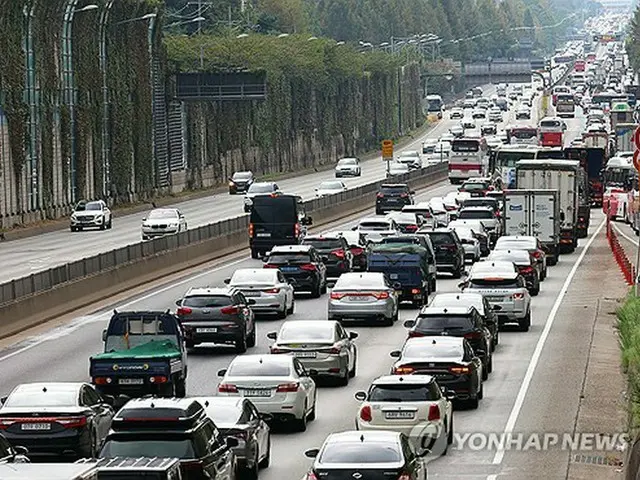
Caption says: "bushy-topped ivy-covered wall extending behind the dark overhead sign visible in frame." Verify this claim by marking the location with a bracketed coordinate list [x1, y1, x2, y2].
[165, 35, 424, 189]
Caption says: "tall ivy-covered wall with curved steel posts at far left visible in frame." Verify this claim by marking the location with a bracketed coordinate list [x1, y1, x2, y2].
[0, 0, 163, 228]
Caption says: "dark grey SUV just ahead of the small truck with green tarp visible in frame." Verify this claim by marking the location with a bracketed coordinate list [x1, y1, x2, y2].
[176, 287, 256, 353]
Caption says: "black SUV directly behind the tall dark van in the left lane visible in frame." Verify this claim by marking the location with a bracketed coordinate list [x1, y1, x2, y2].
[264, 245, 327, 298]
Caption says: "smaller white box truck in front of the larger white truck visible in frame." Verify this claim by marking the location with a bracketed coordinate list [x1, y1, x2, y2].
[502, 190, 561, 265]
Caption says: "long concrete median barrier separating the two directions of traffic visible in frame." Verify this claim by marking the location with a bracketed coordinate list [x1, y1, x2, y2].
[0, 164, 447, 338]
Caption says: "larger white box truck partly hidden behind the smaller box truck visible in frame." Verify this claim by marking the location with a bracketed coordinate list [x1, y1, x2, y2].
[516, 160, 581, 253]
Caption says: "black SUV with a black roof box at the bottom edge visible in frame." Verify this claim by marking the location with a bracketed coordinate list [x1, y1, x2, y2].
[99, 398, 239, 480]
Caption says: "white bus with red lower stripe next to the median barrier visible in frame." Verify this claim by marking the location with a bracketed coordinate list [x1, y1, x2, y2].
[449, 137, 488, 184]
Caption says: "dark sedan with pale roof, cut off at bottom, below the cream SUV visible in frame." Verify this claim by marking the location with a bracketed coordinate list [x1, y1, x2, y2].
[304, 431, 427, 480]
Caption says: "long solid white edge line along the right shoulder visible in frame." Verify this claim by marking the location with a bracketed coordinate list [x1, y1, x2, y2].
[492, 220, 606, 465]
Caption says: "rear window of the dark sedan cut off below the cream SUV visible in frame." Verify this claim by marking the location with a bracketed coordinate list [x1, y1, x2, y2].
[319, 442, 402, 464]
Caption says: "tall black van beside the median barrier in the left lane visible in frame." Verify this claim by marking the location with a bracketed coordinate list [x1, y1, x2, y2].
[249, 195, 312, 258]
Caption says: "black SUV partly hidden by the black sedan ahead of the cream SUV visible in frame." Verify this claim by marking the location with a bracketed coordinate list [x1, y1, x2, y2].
[404, 306, 493, 380]
